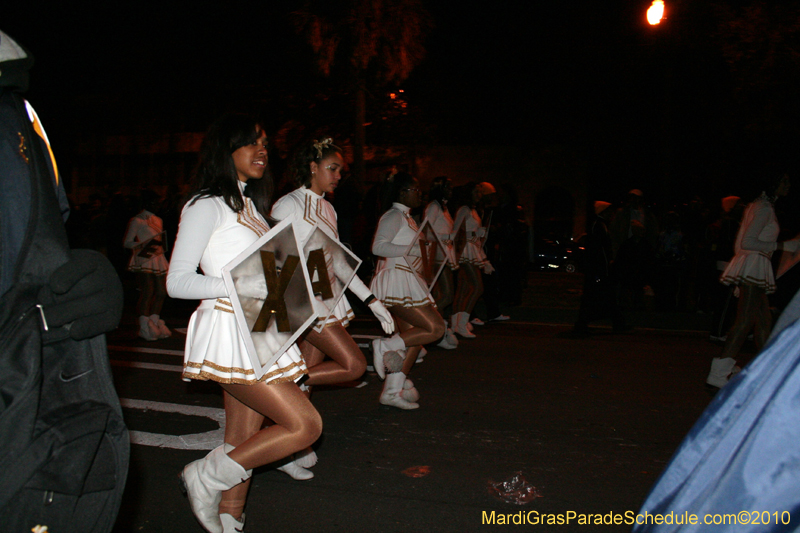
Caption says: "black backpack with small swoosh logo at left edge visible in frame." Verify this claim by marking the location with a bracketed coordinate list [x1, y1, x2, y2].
[0, 88, 130, 533]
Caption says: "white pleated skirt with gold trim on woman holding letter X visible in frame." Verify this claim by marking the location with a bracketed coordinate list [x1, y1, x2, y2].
[183, 299, 308, 385]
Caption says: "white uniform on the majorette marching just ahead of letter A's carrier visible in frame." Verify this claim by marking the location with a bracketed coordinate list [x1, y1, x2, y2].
[370, 202, 435, 307]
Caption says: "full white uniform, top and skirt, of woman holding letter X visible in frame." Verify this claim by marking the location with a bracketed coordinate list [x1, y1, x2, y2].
[167, 182, 308, 384]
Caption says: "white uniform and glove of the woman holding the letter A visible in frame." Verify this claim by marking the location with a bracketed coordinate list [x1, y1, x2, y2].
[271, 186, 371, 327]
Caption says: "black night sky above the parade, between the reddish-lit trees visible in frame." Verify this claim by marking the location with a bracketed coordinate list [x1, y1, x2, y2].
[6, 0, 800, 209]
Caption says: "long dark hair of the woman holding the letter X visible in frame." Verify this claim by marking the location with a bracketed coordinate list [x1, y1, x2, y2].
[188, 114, 272, 220]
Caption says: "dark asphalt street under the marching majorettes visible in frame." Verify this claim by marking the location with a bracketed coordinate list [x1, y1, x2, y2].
[108, 273, 752, 533]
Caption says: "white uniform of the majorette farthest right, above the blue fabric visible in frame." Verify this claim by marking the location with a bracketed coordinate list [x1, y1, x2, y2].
[720, 193, 780, 294]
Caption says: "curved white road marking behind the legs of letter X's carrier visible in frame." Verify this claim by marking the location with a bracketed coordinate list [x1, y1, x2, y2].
[120, 398, 225, 450]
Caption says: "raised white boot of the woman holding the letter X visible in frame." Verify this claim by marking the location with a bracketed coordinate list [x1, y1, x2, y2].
[181, 445, 252, 533]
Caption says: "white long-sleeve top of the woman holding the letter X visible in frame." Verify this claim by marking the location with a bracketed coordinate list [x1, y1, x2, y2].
[167, 182, 269, 300]
